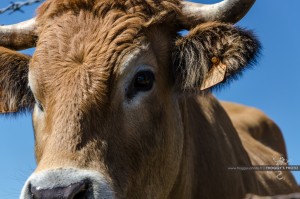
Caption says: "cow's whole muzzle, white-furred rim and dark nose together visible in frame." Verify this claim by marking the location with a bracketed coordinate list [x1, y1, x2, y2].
[20, 168, 115, 199]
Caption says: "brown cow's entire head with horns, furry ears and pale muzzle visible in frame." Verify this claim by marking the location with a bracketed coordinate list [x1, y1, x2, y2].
[0, 0, 259, 199]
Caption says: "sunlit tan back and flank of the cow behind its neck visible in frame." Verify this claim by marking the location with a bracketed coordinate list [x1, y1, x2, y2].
[222, 102, 298, 195]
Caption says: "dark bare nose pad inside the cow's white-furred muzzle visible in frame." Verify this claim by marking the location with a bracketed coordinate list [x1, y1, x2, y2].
[30, 181, 88, 199]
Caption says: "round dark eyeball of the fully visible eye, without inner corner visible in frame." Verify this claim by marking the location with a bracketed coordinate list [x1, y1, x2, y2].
[134, 71, 154, 91]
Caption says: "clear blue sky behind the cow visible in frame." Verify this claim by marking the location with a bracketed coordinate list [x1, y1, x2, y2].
[0, 0, 300, 199]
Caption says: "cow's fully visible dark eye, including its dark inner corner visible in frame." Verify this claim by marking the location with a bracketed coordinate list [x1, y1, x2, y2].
[126, 70, 155, 99]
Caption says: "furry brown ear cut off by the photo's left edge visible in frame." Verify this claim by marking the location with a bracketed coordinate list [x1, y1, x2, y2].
[0, 47, 34, 113]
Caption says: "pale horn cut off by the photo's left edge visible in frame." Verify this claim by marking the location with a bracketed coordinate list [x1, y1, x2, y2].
[0, 18, 37, 50]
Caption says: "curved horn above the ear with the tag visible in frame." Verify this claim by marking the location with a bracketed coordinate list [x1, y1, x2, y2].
[182, 0, 255, 27]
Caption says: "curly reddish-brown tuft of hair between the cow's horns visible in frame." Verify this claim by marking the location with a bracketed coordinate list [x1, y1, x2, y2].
[37, 0, 181, 28]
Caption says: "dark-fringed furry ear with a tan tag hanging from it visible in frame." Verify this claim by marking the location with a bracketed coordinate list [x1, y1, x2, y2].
[172, 22, 260, 90]
